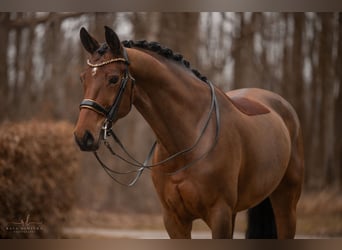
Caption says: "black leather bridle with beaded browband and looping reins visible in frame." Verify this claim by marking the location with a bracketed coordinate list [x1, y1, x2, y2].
[80, 48, 220, 187]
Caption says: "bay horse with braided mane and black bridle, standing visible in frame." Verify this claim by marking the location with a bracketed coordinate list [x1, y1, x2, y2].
[74, 27, 304, 239]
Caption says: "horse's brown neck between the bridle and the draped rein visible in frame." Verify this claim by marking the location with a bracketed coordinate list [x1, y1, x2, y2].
[127, 49, 211, 154]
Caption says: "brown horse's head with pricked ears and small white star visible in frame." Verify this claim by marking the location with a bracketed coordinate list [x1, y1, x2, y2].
[74, 27, 134, 151]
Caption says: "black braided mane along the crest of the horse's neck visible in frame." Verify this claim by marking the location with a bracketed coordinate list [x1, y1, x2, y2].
[122, 40, 208, 83]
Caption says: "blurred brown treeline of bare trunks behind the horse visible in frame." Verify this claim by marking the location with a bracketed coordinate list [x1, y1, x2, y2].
[0, 13, 342, 212]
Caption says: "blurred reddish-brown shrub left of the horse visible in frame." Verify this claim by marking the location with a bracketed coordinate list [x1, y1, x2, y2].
[0, 121, 79, 238]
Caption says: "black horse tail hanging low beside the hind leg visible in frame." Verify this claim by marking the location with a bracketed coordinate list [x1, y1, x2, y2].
[246, 198, 277, 239]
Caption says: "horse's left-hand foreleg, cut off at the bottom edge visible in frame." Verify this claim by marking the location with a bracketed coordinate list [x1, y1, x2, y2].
[163, 212, 192, 239]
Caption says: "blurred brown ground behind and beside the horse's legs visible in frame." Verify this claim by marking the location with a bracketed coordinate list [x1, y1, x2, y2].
[63, 191, 342, 238]
